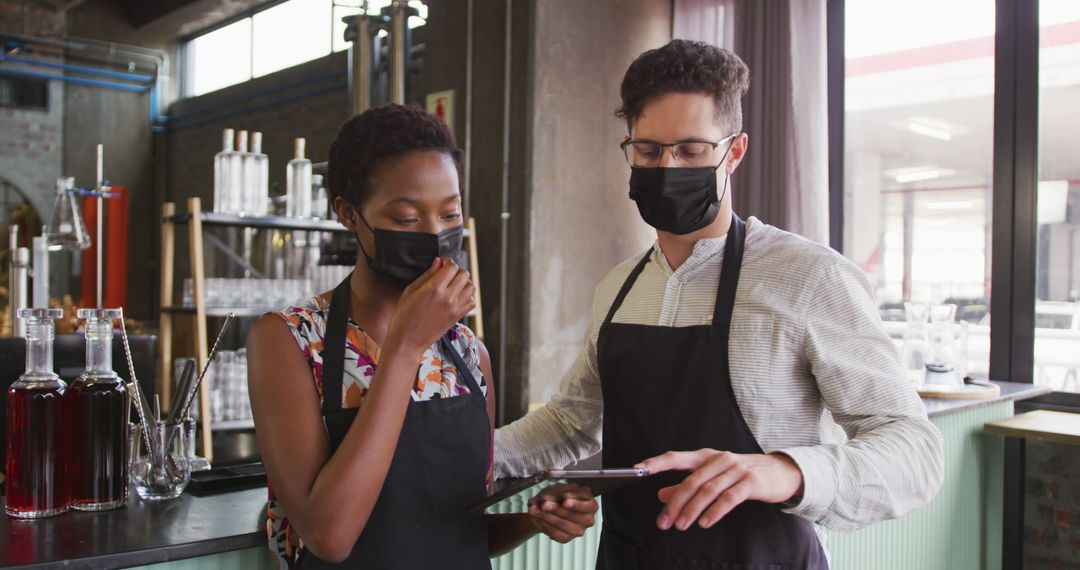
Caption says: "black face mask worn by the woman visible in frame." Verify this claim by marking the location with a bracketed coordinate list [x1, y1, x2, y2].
[356, 218, 464, 289]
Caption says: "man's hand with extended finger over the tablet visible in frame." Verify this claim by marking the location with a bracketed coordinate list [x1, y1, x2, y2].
[635, 449, 802, 530]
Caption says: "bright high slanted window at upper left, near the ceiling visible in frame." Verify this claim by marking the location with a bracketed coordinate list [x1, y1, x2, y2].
[184, 0, 428, 96]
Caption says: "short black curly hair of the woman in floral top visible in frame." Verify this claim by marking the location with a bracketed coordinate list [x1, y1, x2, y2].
[326, 104, 461, 209]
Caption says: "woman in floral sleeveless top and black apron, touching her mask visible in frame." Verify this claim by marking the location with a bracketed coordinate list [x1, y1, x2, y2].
[247, 105, 596, 569]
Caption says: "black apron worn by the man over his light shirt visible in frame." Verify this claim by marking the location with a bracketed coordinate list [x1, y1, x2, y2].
[596, 215, 827, 570]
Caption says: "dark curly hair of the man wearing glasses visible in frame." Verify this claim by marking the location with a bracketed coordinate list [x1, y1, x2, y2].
[615, 40, 750, 133]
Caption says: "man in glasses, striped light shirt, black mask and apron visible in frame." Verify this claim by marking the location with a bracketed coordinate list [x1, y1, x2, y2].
[495, 40, 944, 569]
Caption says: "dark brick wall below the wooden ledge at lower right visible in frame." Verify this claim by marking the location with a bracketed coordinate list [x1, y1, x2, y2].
[1024, 444, 1080, 569]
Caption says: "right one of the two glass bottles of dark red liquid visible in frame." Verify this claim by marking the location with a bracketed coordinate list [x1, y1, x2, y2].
[67, 309, 131, 511]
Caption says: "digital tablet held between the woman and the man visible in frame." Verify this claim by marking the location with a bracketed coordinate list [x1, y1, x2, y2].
[469, 469, 649, 514]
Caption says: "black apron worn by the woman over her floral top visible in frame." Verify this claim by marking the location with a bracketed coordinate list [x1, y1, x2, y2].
[296, 277, 491, 570]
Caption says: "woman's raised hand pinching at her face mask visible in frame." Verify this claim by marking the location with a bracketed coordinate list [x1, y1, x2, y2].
[386, 258, 476, 352]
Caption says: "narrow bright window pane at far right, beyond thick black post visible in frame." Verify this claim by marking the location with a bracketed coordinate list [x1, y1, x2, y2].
[1035, 0, 1080, 392]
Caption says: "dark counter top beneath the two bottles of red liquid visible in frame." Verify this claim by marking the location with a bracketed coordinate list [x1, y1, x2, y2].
[0, 488, 267, 568]
